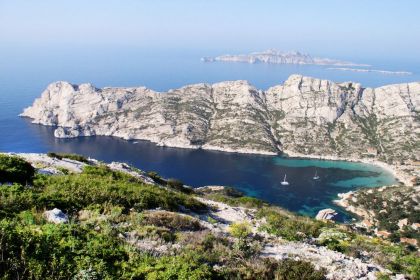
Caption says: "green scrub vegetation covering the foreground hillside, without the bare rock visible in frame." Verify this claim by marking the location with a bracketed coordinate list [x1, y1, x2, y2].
[0, 155, 420, 280]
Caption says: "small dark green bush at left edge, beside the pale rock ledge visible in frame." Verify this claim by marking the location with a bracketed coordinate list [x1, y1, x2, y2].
[0, 154, 35, 185]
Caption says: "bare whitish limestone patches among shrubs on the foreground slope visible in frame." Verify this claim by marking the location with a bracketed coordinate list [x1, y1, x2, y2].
[0, 153, 408, 279]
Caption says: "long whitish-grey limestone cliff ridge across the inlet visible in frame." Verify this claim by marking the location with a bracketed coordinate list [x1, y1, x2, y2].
[22, 75, 420, 162]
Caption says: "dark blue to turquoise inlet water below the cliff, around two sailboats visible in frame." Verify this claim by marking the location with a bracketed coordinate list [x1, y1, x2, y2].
[9, 119, 397, 222]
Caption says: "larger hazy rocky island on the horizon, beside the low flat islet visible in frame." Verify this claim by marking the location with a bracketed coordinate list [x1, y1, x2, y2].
[201, 49, 370, 67]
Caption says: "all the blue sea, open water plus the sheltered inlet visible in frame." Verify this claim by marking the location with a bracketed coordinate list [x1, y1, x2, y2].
[0, 46, 420, 221]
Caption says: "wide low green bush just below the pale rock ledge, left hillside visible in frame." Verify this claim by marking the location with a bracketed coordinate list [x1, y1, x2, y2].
[34, 170, 206, 213]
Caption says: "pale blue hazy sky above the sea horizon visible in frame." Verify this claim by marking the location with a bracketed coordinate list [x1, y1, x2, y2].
[0, 0, 420, 58]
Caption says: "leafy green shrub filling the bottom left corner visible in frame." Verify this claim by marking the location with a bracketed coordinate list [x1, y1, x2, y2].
[0, 220, 128, 279]
